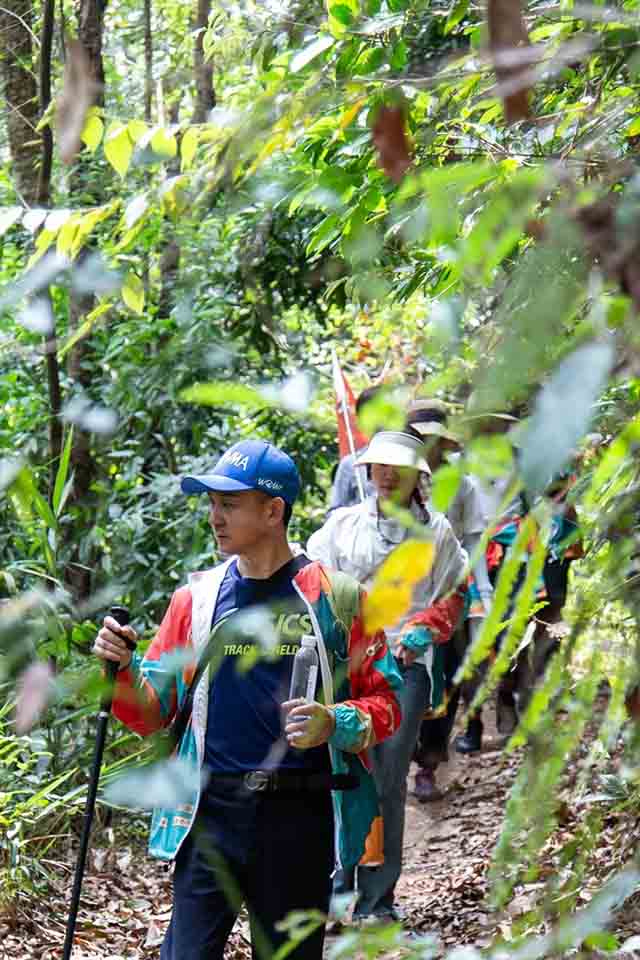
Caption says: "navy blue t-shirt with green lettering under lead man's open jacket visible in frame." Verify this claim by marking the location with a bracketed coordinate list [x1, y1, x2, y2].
[204, 557, 329, 773]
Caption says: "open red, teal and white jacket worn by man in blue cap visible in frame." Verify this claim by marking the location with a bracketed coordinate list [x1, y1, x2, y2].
[113, 561, 402, 866]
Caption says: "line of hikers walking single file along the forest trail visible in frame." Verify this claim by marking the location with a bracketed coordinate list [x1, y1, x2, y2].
[94, 388, 577, 960]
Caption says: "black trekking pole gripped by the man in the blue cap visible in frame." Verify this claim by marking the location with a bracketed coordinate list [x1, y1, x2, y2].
[62, 607, 133, 960]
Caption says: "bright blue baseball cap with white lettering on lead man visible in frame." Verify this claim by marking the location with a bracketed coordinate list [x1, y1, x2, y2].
[180, 440, 300, 506]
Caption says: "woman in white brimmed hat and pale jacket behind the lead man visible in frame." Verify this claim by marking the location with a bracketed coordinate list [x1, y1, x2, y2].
[307, 431, 467, 920]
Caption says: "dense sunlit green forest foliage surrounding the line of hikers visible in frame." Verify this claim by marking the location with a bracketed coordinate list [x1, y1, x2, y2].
[0, 0, 640, 955]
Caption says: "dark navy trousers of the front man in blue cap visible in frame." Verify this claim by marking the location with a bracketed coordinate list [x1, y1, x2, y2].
[160, 779, 334, 960]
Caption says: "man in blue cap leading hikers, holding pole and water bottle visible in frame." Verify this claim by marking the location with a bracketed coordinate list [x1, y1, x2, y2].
[94, 440, 402, 960]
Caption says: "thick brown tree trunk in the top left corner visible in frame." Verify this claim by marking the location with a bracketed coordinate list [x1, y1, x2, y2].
[0, 0, 41, 206]
